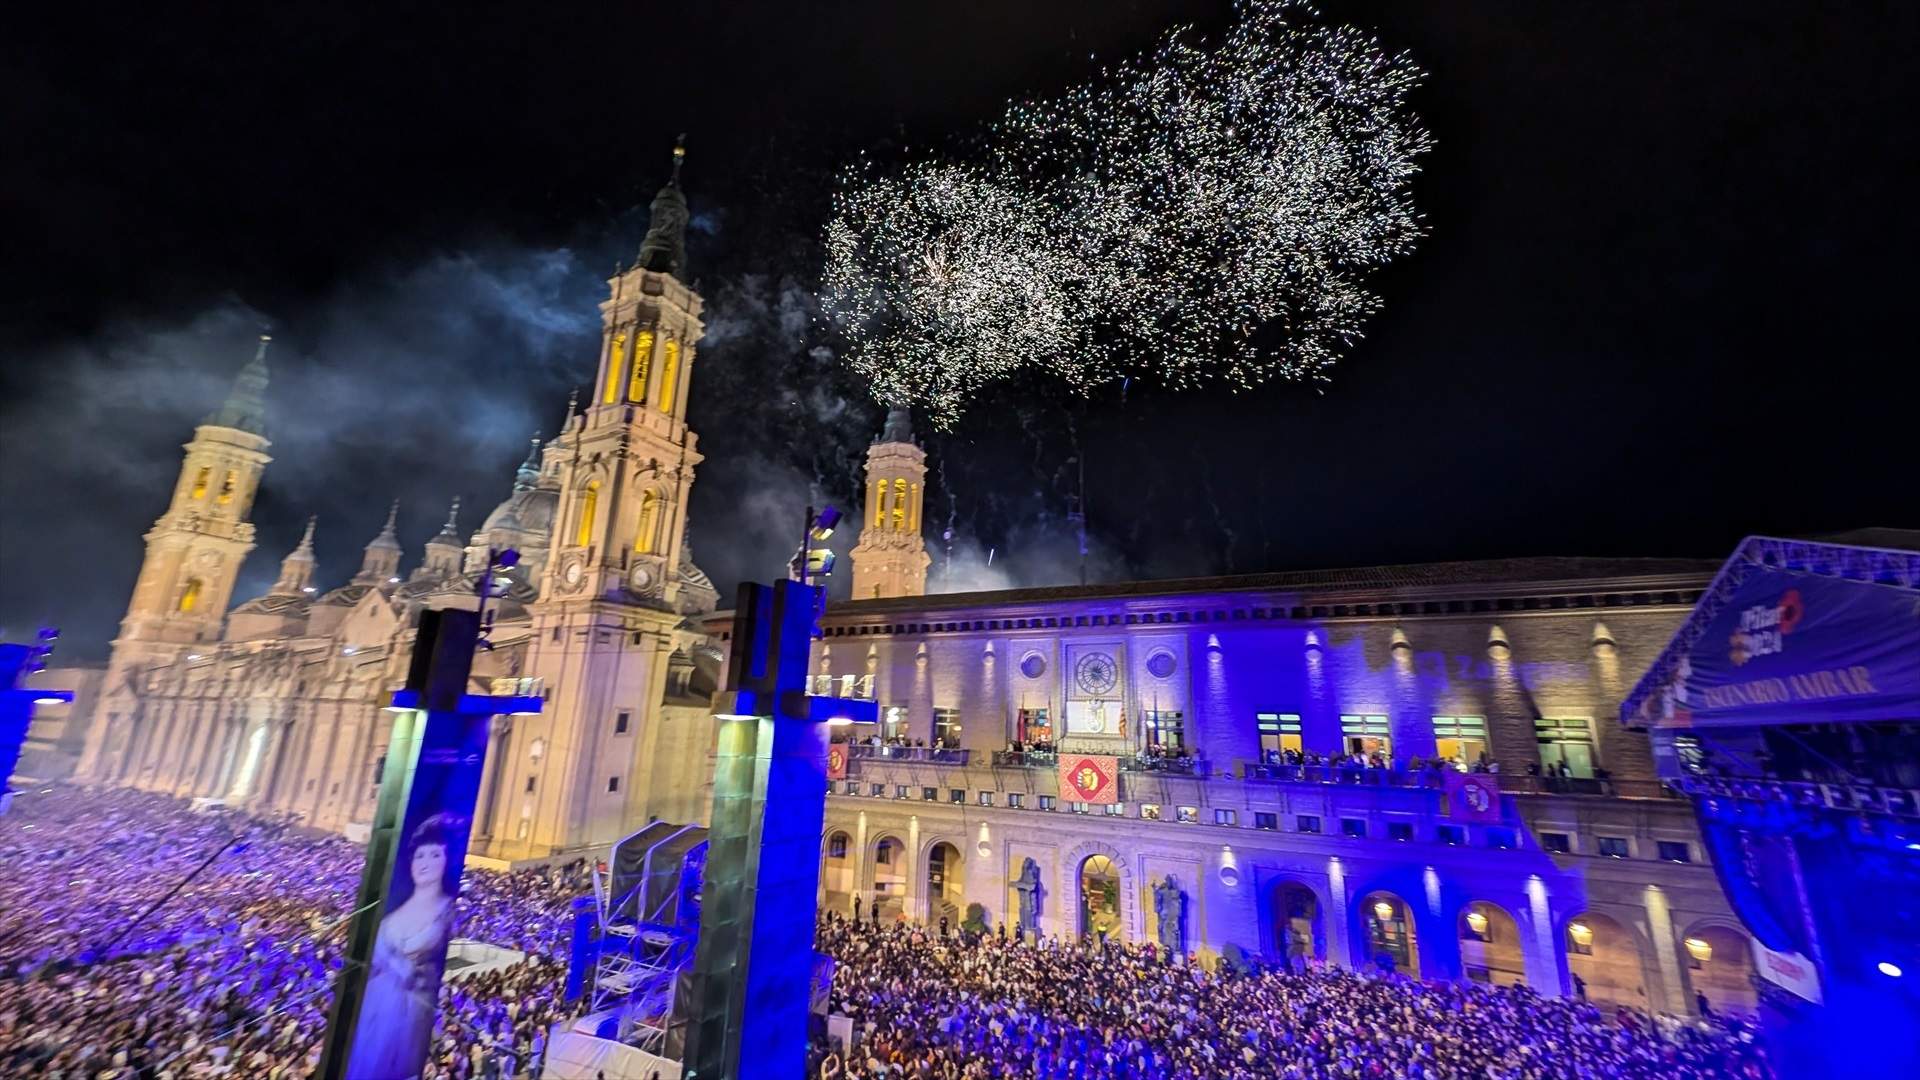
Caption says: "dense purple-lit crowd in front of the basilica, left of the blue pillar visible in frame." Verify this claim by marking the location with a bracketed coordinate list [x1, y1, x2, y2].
[0, 786, 588, 1080]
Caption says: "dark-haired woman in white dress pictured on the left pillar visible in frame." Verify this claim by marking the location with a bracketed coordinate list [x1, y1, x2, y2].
[348, 813, 467, 1080]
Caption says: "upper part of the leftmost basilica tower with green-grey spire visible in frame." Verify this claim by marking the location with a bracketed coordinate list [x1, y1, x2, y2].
[113, 334, 271, 651]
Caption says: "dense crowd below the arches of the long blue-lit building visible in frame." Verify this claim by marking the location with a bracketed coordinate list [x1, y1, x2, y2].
[810, 917, 1766, 1080]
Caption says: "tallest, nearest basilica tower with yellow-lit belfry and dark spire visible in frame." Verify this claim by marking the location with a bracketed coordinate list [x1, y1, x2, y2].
[491, 146, 710, 859]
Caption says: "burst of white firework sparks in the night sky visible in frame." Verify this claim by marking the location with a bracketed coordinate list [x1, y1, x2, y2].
[822, 0, 1432, 427]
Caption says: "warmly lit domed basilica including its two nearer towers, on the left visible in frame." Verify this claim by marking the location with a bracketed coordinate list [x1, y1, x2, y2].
[63, 150, 718, 863]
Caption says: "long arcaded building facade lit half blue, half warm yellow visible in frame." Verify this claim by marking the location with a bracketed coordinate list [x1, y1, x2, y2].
[814, 545, 1753, 1013]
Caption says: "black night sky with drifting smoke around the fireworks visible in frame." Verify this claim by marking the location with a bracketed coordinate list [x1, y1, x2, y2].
[0, 0, 1920, 655]
